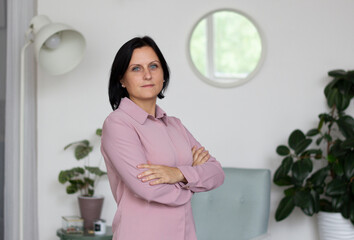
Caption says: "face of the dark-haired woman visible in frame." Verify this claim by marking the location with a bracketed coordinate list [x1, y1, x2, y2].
[120, 46, 163, 103]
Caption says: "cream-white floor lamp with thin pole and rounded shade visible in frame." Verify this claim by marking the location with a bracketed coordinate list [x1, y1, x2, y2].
[19, 15, 86, 240]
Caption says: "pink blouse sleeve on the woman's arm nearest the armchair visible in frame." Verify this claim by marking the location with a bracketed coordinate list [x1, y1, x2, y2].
[178, 122, 225, 192]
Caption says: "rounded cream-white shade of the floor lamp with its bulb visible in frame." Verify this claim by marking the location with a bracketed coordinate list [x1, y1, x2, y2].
[31, 15, 86, 75]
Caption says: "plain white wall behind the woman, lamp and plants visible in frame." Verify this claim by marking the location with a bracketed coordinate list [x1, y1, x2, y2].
[38, 0, 354, 240]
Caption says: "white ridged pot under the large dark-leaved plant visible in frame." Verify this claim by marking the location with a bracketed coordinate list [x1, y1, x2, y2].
[317, 212, 354, 240]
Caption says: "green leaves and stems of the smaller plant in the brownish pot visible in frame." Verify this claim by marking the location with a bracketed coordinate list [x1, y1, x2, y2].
[58, 129, 107, 197]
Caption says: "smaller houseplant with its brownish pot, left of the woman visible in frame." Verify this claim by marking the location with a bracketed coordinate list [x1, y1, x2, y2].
[58, 129, 107, 229]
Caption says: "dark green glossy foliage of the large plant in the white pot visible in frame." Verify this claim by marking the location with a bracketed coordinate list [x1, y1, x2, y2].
[273, 70, 354, 224]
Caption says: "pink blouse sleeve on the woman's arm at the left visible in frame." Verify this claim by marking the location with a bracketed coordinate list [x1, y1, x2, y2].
[101, 115, 193, 206]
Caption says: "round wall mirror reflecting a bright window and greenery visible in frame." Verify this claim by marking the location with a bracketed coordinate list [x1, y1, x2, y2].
[188, 10, 264, 87]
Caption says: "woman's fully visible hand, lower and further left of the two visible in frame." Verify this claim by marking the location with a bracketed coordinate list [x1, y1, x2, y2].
[137, 164, 186, 185]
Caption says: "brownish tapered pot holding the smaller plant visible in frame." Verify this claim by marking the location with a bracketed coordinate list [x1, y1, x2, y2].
[78, 196, 104, 230]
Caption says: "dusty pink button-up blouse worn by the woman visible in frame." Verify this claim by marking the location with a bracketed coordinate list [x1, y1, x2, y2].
[101, 98, 224, 240]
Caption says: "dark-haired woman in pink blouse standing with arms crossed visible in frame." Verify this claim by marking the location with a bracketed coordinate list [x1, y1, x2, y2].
[101, 37, 224, 240]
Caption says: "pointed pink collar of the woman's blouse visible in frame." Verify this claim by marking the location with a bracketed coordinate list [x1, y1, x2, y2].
[119, 97, 167, 124]
